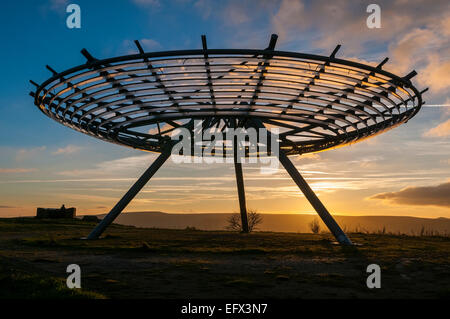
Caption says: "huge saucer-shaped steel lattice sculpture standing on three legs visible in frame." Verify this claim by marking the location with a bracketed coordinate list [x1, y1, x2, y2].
[30, 35, 425, 244]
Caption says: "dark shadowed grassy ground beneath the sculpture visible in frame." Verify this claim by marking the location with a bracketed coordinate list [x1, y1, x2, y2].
[0, 218, 450, 299]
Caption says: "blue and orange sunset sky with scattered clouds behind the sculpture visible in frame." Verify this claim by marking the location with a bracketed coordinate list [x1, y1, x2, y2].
[0, 0, 450, 218]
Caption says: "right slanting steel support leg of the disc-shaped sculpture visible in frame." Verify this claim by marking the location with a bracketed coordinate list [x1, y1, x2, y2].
[279, 149, 352, 245]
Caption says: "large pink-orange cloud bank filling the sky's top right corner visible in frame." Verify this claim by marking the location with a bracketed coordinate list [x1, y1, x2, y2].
[271, 0, 450, 93]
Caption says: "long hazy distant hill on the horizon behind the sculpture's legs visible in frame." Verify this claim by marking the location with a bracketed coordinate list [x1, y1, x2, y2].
[99, 212, 450, 234]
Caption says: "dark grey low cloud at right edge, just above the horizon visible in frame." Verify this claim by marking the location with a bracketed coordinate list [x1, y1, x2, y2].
[369, 182, 450, 207]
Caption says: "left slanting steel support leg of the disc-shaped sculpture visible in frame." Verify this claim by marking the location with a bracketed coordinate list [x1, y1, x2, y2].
[87, 150, 170, 239]
